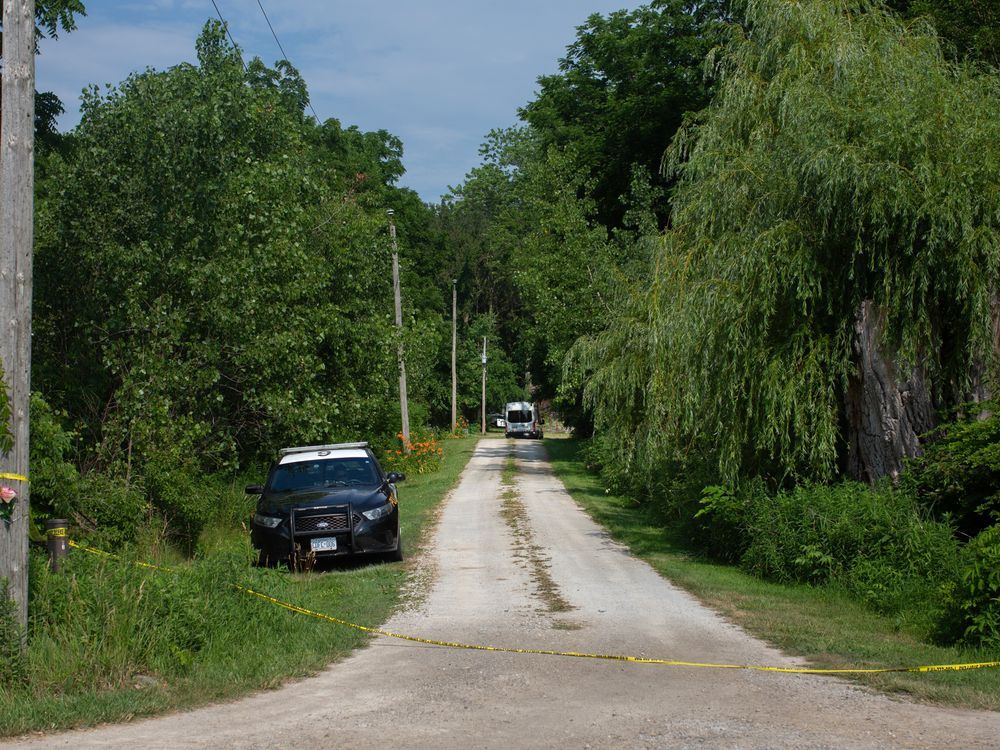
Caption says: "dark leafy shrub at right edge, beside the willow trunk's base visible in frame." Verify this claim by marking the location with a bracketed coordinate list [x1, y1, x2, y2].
[911, 401, 1000, 536]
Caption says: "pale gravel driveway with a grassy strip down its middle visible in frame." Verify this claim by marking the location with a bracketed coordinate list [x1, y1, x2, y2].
[4, 440, 1000, 749]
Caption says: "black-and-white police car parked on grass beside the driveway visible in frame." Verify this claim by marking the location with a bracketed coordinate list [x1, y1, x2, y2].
[246, 443, 406, 570]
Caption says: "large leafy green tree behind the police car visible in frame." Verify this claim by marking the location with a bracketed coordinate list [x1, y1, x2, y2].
[36, 24, 406, 482]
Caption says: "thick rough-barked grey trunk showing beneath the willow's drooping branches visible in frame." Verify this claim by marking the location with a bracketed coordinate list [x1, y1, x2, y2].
[846, 300, 935, 482]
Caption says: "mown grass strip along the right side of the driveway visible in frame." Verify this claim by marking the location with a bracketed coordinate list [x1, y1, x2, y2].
[545, 439, 1000, 711]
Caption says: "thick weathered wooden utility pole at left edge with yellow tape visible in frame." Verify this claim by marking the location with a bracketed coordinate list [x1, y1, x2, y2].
[0, 0, 35, 626]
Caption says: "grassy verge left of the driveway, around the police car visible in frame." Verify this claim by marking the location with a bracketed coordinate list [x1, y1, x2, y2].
[0, 439, 476, 737]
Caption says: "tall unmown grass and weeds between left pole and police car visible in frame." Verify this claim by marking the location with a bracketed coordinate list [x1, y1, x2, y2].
[22, 553, 273, 692]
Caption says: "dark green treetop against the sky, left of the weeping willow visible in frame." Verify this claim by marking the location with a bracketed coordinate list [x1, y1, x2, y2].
[521, 0, 726, 227]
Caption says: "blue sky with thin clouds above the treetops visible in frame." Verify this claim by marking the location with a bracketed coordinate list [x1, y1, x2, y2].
[37, 0, 640, 202]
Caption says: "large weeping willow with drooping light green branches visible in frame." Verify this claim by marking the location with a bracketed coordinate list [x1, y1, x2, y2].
[567, 0, 1000, 488]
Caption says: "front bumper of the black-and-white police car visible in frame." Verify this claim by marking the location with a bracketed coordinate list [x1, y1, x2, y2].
[250, 503, 399, 564]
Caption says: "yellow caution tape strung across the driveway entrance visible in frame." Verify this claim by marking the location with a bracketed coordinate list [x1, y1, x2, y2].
[69, 541, 1000, 675]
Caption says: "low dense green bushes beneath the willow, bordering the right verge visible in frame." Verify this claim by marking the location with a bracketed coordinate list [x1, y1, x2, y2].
[694, 480, 964, 641]
